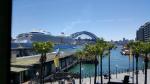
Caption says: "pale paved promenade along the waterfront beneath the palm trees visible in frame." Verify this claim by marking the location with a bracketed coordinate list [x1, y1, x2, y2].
[45, 69, 150, 84]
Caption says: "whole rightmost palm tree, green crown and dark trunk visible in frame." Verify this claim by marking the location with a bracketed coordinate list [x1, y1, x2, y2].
[142, 42, 150, 84]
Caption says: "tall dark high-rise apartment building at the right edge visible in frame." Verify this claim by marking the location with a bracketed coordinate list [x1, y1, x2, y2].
[136, 22, 150, 41]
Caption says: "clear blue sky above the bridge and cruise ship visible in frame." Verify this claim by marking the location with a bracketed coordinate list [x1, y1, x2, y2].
[12, 0, 150, 40]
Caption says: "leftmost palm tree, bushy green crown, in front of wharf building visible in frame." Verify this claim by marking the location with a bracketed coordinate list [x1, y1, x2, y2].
[32, 42, 53, 84]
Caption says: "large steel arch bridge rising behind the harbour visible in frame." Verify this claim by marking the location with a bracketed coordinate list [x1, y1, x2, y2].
[70, 31, 98, 41]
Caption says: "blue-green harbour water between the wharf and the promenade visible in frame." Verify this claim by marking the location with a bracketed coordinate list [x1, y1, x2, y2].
[68, 46, 144, 76]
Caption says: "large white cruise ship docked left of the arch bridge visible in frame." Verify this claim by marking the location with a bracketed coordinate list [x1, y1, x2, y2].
[15, 31, 75, 44]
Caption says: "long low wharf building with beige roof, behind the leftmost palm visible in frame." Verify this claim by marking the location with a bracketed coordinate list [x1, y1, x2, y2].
[11, 52, 76, 83]
